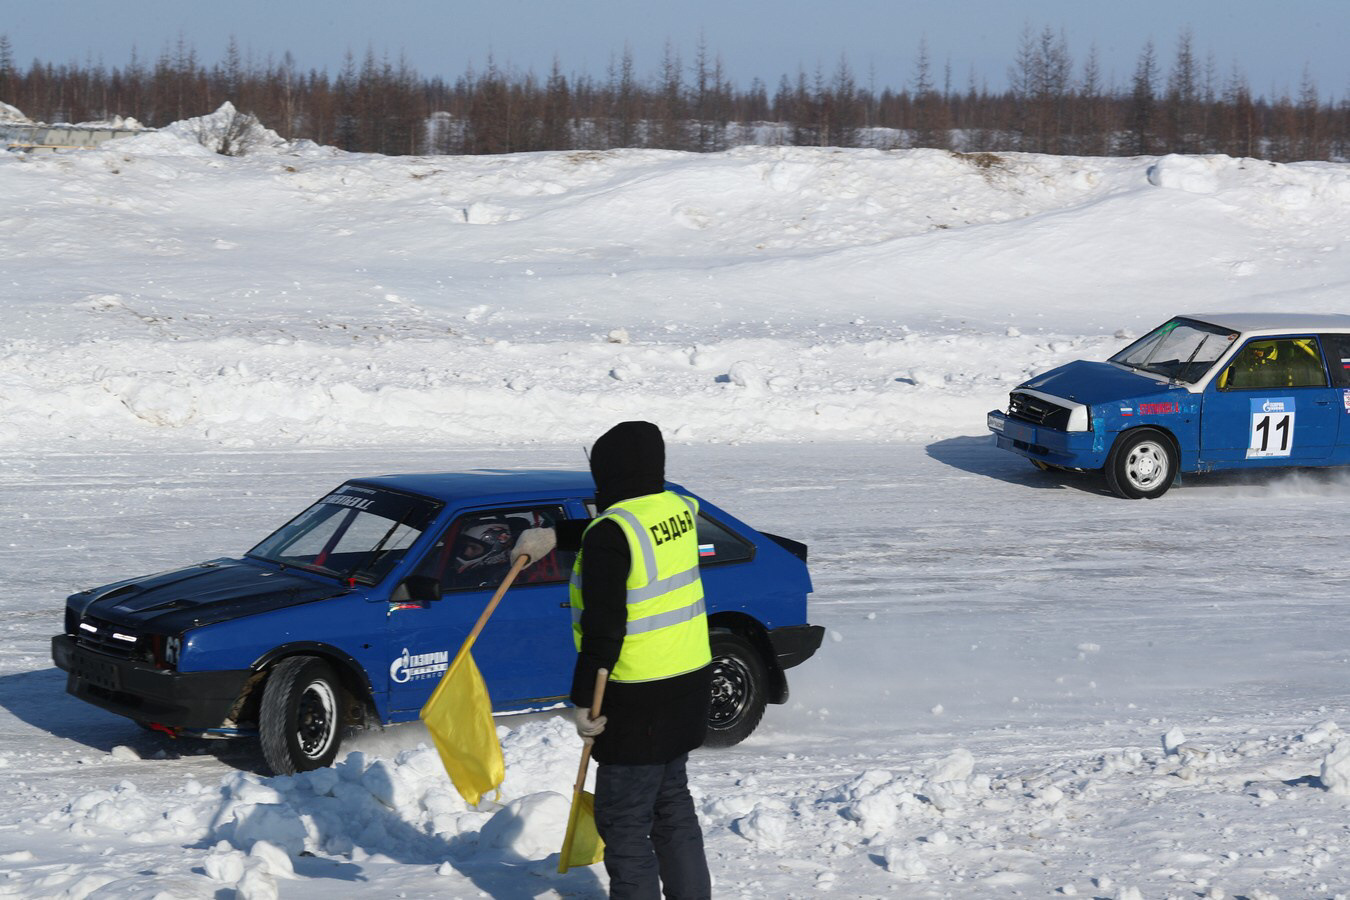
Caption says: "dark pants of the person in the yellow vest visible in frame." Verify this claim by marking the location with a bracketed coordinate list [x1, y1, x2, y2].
[595, 754, 713, 900]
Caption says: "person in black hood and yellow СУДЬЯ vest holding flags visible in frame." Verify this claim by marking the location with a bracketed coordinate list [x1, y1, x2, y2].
[571, 422, 711, 900]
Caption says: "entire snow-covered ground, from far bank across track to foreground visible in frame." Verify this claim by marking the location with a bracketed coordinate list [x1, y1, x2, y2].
[0, 109, 1350, 900]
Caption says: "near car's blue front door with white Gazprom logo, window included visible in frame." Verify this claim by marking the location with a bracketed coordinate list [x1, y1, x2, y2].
[386, 502, 576, 718]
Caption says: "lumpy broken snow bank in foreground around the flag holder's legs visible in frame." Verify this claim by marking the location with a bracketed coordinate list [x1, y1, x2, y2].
[23, 716, 1350, 897]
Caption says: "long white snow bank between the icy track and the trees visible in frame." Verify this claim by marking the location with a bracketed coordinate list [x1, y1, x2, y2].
[0, 132, 1350, 449]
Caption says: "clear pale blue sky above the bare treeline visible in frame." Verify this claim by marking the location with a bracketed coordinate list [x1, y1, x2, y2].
[0, 0, 1350, 100]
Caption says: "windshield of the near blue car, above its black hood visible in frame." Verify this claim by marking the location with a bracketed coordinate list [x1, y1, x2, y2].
[248, 484, 440, 584]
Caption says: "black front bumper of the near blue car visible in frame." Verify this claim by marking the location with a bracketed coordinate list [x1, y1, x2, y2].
[51, 634, 252, 730]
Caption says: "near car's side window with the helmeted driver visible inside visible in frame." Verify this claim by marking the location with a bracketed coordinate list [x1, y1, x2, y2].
[417, 505, 576, 591]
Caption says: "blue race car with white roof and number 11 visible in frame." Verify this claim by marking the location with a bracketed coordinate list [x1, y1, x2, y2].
[988, 313, 1350, 499]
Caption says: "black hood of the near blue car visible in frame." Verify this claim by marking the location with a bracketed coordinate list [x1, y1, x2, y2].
[70, 559, 350, 633]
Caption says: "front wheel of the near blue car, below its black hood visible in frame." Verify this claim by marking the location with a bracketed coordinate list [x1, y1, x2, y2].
[258, 656, 343, 775]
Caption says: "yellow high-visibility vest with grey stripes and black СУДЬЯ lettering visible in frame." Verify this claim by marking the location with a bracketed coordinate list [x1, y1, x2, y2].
[570, 491, 713, 681]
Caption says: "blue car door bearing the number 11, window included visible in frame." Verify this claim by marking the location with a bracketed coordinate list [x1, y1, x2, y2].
[1200, 335, 1342, 466]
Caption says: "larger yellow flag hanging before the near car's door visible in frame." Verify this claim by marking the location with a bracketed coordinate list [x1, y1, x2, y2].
[419, 653, 506, 806]
